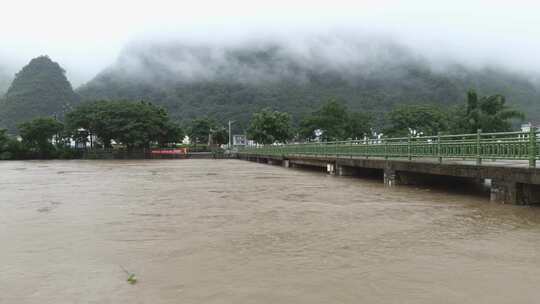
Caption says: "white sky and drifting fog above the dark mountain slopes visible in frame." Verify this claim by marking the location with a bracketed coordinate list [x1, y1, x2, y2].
[0, 0, 540, 86]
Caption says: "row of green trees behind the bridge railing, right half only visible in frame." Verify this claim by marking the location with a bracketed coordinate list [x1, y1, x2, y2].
[247, 90, 524, 144]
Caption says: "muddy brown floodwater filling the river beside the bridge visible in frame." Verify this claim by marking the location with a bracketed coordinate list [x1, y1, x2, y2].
[0, 160, 540, 304]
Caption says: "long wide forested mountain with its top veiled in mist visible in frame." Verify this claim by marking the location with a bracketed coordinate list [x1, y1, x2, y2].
[78, 41, 540, 125]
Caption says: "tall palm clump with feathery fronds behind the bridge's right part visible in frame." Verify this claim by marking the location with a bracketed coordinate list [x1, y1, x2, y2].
[451, 90, 525, 133]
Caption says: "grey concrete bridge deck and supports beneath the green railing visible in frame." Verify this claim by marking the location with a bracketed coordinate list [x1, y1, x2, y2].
[237, 152, 540, 204]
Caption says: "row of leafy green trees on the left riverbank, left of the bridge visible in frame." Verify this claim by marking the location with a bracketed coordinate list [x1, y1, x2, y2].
[0, 101, 228, 160]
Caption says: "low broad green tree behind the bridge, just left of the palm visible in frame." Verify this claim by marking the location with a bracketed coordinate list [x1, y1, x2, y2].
[384, 105, 448, 137]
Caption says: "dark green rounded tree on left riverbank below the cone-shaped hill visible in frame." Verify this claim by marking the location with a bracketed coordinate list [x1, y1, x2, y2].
[18, 117, 64, 158]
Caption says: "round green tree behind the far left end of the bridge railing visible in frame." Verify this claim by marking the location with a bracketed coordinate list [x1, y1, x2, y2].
[247, 108, 292, 144]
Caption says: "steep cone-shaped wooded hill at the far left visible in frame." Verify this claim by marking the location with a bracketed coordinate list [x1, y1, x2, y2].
[0, 56, 79, 133]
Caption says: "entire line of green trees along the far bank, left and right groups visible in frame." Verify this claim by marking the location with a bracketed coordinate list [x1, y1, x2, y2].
[0, 91, 524, 159]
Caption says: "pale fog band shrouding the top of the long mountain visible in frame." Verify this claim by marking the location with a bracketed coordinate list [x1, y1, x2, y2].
[104, 30, 429, 86]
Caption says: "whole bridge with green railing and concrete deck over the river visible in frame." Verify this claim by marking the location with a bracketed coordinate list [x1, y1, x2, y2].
[237, 128, 540, 204]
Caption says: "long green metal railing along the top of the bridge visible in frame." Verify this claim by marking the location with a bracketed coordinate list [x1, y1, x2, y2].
[238, 128, 540, 168]
